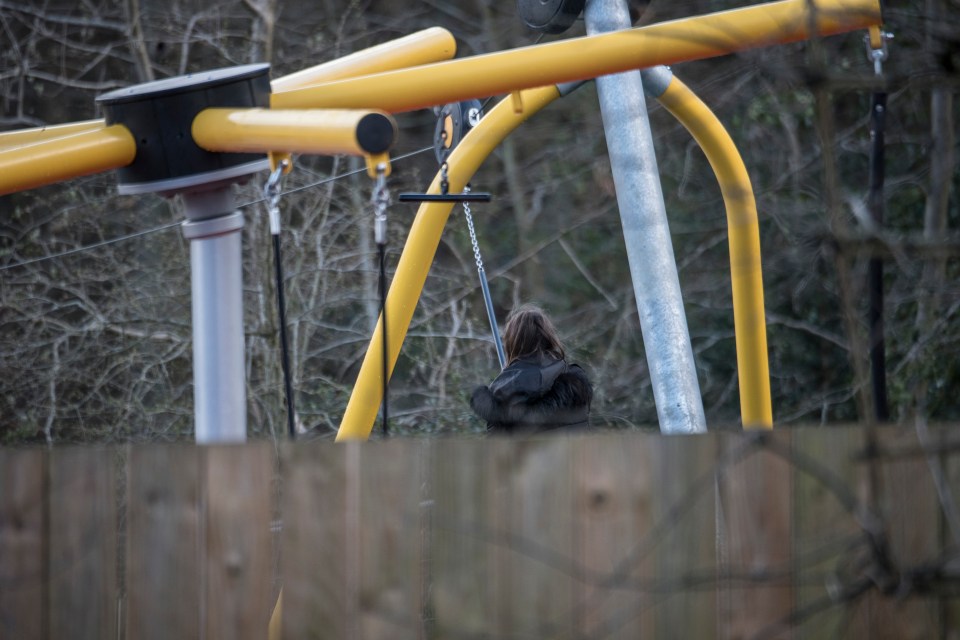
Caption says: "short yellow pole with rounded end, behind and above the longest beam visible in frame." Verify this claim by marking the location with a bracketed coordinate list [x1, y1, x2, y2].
[270, 27, 457, 93]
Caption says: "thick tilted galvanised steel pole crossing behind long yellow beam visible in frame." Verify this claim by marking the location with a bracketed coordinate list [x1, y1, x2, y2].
[584, 0, 707, 434]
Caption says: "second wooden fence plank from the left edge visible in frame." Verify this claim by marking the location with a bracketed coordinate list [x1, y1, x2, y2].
[49, 447, 118, 640]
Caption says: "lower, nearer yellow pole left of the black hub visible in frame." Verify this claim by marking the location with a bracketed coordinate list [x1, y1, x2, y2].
[0, 124, 137, 195]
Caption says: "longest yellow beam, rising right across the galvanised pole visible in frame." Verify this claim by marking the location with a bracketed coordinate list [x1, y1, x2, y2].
[270, 0, 881, 112]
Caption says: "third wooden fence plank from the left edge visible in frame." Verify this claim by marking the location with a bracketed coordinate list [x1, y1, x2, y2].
[126, 445, 204, 640]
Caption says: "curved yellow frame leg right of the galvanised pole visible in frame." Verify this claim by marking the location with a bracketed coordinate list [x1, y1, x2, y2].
[658, 77, 773, 429]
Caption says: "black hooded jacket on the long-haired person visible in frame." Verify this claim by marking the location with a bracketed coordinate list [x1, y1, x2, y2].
[470, 356, 593, 433]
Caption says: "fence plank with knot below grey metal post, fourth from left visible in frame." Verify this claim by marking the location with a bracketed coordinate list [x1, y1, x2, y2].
[202, 442, 274, 640]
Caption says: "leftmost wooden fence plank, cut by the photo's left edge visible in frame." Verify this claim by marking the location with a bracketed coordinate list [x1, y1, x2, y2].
[0, 449, 48, 640]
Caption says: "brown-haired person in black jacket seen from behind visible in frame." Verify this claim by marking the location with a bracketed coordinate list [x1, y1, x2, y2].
[470, 305, 593, 433]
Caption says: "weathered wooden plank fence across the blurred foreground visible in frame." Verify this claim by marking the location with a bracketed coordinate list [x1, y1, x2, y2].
[0, 427, 960, 640]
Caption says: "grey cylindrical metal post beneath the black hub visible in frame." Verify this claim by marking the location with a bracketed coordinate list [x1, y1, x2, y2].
[183, 186, 247, 444]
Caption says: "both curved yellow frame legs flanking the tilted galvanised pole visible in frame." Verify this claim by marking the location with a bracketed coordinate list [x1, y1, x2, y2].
[337, 77, 773, 441]
